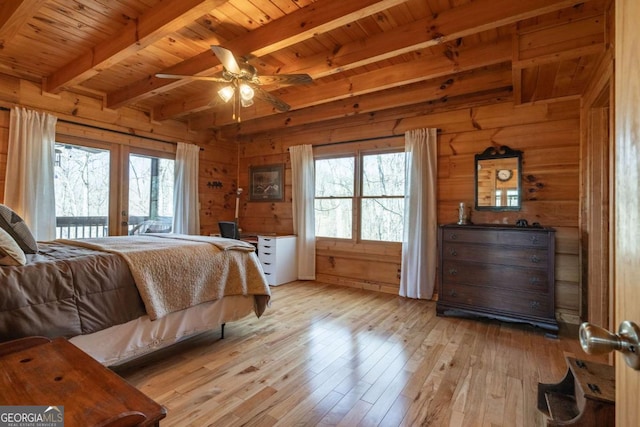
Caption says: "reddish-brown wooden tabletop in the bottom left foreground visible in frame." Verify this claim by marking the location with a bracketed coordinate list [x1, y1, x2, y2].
[0, 337, 166, 427]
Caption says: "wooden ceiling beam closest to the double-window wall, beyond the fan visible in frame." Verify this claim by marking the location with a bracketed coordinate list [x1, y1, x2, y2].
[212, 64, 511, 139]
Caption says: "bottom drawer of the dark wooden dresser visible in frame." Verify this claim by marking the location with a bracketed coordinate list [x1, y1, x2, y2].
[439, 284, 554, 317]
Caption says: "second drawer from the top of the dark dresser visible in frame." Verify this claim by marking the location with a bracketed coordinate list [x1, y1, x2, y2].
[442, 242, 548, 270]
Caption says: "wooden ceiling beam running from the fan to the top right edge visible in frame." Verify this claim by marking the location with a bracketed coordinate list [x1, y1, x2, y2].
[278, 0, 596, 78]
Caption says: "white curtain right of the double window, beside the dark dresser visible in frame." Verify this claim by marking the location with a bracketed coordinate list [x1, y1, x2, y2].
[400, 129, 438, 299]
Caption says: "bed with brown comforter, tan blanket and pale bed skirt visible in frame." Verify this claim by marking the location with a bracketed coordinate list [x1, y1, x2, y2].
[0, 234, 270, 366]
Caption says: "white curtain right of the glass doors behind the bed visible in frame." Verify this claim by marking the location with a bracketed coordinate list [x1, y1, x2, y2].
[172, 142, 200, 235]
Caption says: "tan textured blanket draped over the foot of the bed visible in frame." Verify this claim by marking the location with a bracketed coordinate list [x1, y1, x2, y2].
[57, 234, 270, 320]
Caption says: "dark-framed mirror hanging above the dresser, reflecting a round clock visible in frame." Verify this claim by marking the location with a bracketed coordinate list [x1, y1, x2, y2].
[475, 145, 522, 211]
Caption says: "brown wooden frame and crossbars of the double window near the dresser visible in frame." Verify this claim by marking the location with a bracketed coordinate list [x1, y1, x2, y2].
[313, 146, 406, 244]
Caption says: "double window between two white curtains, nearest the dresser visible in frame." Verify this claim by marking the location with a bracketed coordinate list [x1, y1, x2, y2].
[315, 151, 405, 242]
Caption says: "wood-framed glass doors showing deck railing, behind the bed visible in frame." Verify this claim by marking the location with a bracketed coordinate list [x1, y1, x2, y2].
[54, 137, 174, 239]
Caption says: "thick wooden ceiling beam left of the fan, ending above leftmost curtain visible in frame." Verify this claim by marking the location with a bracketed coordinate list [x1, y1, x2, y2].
[43, 0, 228, 93]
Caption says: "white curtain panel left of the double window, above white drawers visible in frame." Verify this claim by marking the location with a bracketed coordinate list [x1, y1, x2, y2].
[289, 145, 316, 280]
